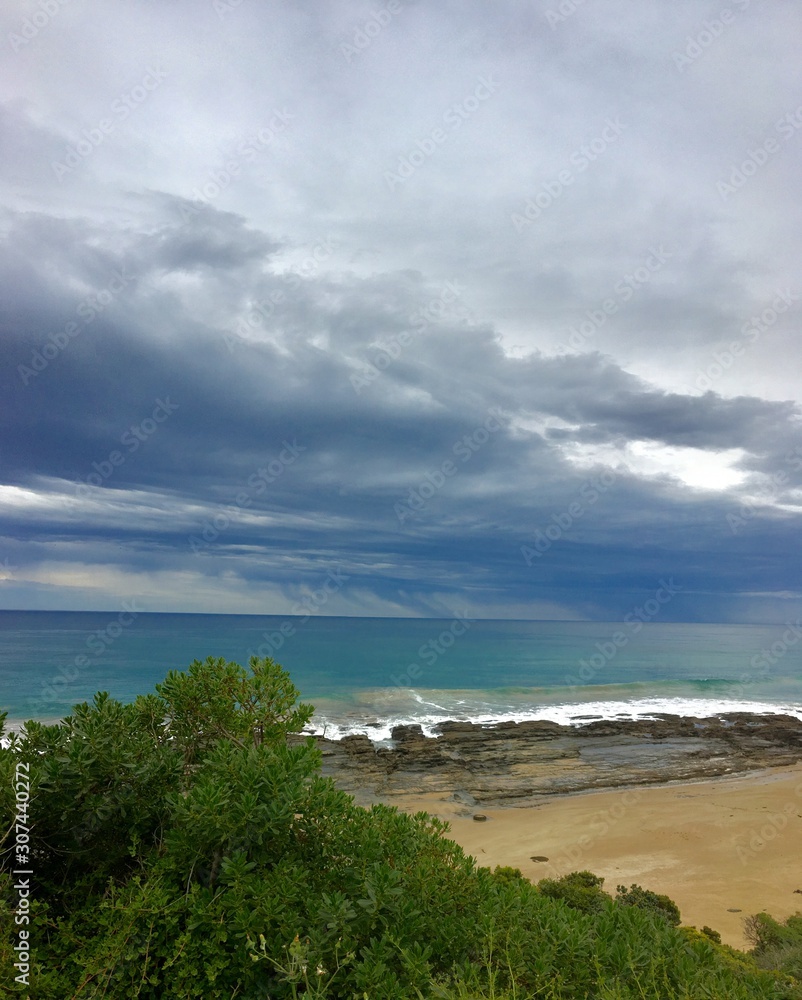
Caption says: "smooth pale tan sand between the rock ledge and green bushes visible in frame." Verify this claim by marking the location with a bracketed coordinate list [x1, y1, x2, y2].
[394, 764, 802, 948]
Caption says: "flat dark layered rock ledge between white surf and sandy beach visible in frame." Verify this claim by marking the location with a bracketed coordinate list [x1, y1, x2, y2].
[296, 713, 802, 810]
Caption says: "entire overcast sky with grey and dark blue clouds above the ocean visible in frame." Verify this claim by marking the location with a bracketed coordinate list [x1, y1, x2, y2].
[0, 0, 802, 622]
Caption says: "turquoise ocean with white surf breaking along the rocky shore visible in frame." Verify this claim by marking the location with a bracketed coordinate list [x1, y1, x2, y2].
[0, 608, 802, 742]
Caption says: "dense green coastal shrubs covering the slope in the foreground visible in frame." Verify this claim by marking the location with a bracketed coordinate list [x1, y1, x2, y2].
[0, 658, 802, 1000]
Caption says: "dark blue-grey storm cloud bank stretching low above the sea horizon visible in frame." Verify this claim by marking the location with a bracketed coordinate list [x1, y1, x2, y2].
[3, 199, 797, 615]
